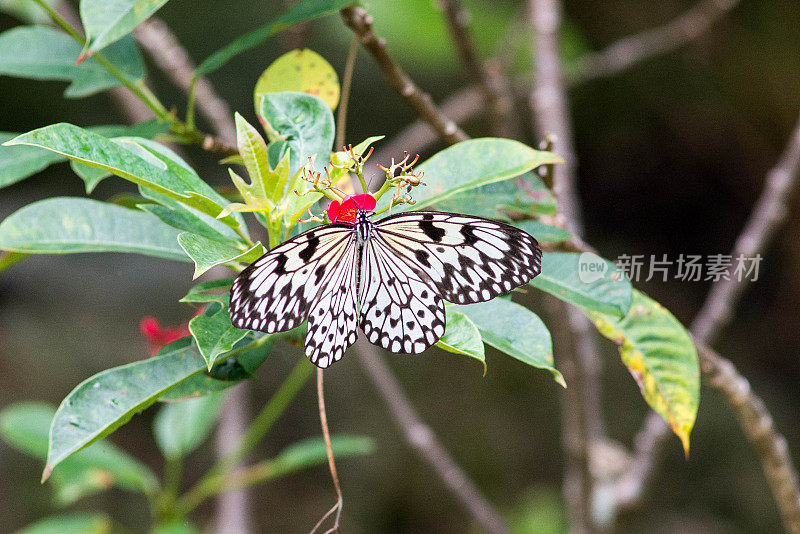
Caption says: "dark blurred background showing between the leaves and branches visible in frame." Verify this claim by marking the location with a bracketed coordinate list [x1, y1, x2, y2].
[0, 0, 800, 533]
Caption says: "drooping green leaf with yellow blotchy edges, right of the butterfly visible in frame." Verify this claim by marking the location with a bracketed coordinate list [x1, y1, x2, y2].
[586, 290, 700, 454]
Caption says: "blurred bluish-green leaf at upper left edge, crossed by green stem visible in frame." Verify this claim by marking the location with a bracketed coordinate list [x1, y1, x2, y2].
[0, 26, 144, 98]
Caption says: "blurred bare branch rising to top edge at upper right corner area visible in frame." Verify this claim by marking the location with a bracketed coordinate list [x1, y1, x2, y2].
[569, 0, 739, 85]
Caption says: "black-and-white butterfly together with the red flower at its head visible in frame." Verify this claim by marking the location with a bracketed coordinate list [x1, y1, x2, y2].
[230, 194, 542, 368]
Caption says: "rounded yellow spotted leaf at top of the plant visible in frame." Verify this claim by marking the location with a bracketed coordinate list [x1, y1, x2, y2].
[254, 49, 340, 111]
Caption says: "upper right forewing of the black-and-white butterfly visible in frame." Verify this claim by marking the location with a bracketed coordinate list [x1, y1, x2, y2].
[375, 211, 542, 304]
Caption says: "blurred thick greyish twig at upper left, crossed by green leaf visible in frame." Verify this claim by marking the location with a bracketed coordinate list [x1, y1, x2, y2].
[133, 17, 236, 145]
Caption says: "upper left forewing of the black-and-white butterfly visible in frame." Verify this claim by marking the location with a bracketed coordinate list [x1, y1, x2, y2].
[230, 224, 356, 334]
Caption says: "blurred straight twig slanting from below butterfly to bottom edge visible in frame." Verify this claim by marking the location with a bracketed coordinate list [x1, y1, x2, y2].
[356, 341, 509, 534]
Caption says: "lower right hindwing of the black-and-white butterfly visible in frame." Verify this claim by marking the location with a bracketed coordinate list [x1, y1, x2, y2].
[358, 232, 445, 354]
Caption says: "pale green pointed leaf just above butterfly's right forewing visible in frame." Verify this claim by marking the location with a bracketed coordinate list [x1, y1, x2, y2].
[378, 138, 562, 213]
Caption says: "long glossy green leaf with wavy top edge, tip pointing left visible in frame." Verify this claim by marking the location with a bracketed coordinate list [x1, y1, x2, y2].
[6, 123, 244, 231]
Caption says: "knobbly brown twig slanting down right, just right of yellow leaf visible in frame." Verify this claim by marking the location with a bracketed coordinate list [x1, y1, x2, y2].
[341, 7, 468, 145]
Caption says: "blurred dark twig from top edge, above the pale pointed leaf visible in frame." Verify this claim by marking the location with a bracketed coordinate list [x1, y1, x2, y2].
[439, 0, 515, 137]
